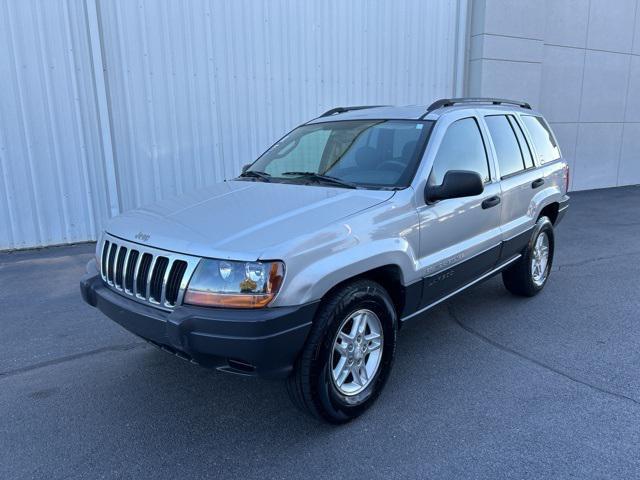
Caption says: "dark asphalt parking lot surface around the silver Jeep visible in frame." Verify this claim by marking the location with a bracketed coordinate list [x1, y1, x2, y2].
[0, 187, 640, 479]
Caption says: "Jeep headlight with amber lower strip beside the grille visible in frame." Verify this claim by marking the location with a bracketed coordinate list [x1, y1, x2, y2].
[184, 259, 284, 308]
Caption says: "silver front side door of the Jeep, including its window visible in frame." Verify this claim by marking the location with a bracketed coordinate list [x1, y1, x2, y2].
[418, 112, 501, 308]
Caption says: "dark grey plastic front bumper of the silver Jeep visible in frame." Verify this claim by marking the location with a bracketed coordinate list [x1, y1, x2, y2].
[80, 266, 318, 378]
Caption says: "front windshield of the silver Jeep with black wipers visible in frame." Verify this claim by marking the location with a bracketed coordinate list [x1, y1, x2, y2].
[243, 120, 434, 188]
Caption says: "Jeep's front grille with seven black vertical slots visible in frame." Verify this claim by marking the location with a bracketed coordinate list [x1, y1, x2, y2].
[100, 235, 199, 310]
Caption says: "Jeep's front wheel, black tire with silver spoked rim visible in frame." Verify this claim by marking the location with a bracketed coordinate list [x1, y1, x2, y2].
[287, 280, 398, 424]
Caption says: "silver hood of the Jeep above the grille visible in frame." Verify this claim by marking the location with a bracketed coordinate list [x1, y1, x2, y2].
[106, 181, 394, 260]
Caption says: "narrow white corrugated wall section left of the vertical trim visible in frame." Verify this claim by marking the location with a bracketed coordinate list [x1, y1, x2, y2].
[0, 0, 107, 249]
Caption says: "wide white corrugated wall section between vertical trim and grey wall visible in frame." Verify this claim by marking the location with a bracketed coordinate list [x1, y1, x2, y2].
[99, 0, 458, 210]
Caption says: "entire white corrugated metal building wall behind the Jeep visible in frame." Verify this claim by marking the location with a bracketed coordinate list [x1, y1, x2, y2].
[0, 0, 466, 249]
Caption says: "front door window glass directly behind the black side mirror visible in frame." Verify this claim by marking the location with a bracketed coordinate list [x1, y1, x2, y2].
[429, 118, 490, 185]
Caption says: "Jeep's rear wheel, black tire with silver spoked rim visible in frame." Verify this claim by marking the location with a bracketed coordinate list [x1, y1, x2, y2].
[502, 217, 555, 297]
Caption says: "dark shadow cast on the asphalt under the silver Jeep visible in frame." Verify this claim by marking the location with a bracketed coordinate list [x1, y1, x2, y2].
[89, 282, 510, 443]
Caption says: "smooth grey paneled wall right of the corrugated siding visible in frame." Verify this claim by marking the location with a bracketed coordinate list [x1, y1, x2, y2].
[468, 0, 640, 190]
